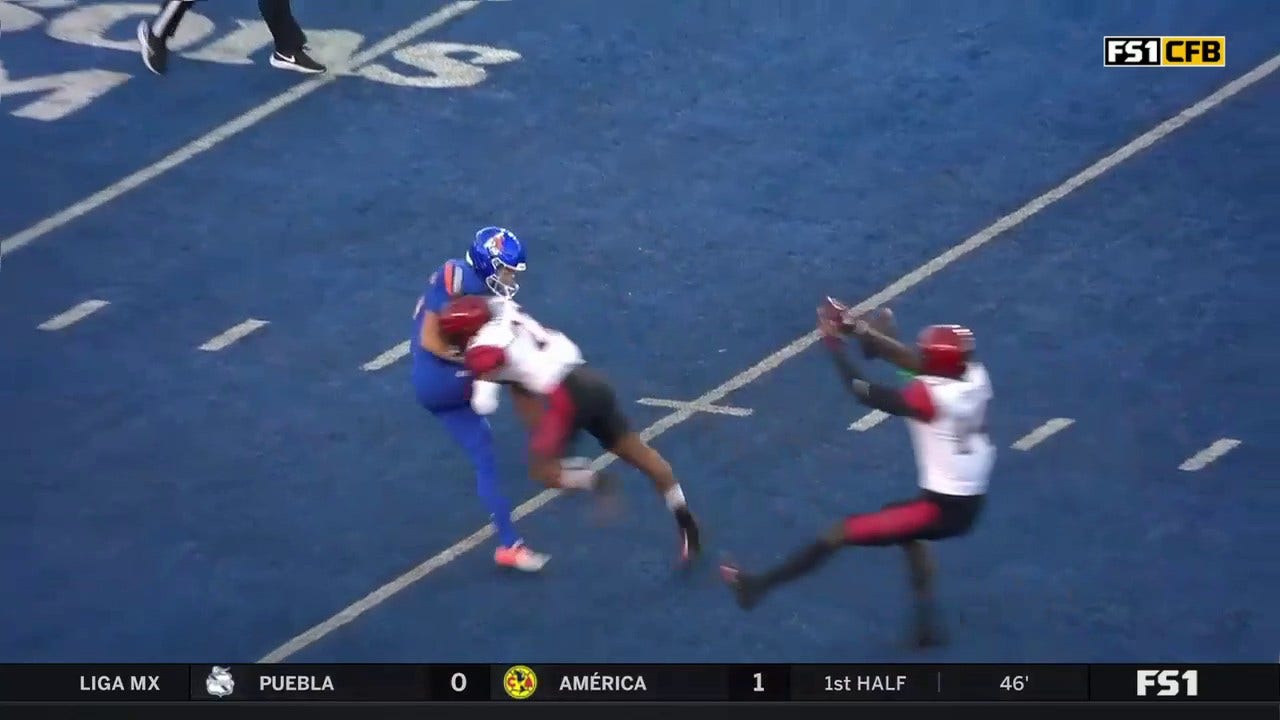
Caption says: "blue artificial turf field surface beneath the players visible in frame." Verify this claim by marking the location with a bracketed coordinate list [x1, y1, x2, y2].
[0, 0, 1280, 662]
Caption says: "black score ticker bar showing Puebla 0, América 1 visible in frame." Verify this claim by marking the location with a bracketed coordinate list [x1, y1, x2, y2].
[0, 664, 1280, 703]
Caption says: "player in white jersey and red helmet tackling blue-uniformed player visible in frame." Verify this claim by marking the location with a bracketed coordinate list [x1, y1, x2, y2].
[439, 296, 701, 562]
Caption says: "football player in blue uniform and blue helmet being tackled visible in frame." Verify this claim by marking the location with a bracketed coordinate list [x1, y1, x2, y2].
[410, 227, 550, 573]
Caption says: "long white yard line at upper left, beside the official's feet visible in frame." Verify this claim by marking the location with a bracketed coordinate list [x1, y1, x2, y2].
[0, 0, 481, 258]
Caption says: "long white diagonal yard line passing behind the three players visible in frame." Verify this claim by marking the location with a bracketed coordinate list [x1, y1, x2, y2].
[259, 50, 1280, 662]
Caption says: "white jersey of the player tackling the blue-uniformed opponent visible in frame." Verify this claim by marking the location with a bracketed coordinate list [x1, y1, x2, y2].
[467, 300, 584, 395]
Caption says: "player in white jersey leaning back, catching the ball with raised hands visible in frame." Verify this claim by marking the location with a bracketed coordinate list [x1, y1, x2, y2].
[721, 302, 996, 647]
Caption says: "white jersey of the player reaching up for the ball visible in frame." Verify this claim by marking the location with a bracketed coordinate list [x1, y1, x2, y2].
[906, 363, 996, 496]
